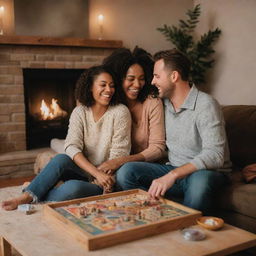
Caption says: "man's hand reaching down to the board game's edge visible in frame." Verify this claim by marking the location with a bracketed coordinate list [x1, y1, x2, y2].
[148, 172, 176, 199]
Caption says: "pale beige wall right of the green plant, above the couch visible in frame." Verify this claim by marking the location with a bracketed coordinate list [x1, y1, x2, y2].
[195, 0, 256, 105]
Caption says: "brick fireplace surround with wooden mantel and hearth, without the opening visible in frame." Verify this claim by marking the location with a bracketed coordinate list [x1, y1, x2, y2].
[0, 36, 122, 179]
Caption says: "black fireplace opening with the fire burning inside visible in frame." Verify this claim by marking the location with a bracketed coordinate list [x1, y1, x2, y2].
[23, 69, 84, 149]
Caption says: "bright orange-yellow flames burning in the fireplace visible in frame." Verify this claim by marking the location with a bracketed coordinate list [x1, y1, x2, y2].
[40, 98, 68, 120]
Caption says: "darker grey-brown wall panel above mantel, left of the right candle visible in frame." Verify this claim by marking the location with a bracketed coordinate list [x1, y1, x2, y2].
[14, 0, 88, 37]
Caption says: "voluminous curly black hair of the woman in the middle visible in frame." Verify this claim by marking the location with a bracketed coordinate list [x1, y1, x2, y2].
[103, 46, 157, 104]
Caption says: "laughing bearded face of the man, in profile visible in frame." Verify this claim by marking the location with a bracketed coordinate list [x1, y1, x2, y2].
[152, 59, 174, 98]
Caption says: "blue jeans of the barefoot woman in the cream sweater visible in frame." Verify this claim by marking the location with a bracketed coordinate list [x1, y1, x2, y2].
[23, 154, 103, 202]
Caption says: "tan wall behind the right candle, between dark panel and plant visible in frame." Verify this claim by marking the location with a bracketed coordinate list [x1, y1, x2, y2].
[88, 0, 193, 53]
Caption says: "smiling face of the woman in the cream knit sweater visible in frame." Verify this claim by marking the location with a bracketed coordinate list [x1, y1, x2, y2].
[91, 72, 115, 106]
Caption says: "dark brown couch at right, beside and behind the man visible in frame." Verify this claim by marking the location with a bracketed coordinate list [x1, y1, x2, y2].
[217, 105, 256, 233]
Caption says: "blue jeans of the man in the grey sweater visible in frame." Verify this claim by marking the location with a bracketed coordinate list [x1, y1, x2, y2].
[116, 162, 228, 214]
